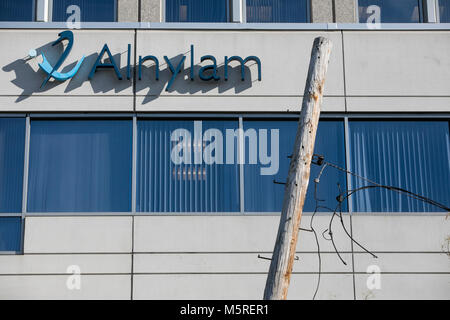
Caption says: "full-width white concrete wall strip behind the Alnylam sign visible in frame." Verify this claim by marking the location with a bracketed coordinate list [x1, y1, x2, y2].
[0, 30, 450, 112]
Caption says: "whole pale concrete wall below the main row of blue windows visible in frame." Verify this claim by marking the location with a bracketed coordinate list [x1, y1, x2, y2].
[0, 214, 450, 299]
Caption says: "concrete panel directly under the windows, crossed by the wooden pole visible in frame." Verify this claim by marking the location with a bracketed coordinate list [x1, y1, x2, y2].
[134, 216, 351, 253]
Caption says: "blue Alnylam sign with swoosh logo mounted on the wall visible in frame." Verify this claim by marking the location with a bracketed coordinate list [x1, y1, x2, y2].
[29, 30, 262, 91]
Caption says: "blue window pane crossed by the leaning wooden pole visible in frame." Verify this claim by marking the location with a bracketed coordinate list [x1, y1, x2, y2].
[244, 120, 347, 212]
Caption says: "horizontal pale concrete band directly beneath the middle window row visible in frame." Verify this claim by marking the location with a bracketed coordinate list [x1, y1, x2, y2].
[24, 215, 450, 254]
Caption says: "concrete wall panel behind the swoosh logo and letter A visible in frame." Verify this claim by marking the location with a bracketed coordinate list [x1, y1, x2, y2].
[0, 29, 134, 111]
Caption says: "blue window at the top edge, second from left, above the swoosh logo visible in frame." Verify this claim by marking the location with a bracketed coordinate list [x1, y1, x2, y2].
[52, 0, 117, 22]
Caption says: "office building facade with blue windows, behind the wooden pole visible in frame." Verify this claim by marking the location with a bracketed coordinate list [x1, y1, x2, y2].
[0, 0, 450, 300]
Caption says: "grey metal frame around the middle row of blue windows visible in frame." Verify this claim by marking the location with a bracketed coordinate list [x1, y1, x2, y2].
[0, 112, 450, 219]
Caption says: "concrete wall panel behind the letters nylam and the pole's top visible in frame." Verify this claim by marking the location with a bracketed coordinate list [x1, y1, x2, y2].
[136, 31, 343, 111]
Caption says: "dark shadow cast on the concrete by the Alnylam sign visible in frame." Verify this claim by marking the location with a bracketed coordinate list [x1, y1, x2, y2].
[2, 42, 257, 104]
